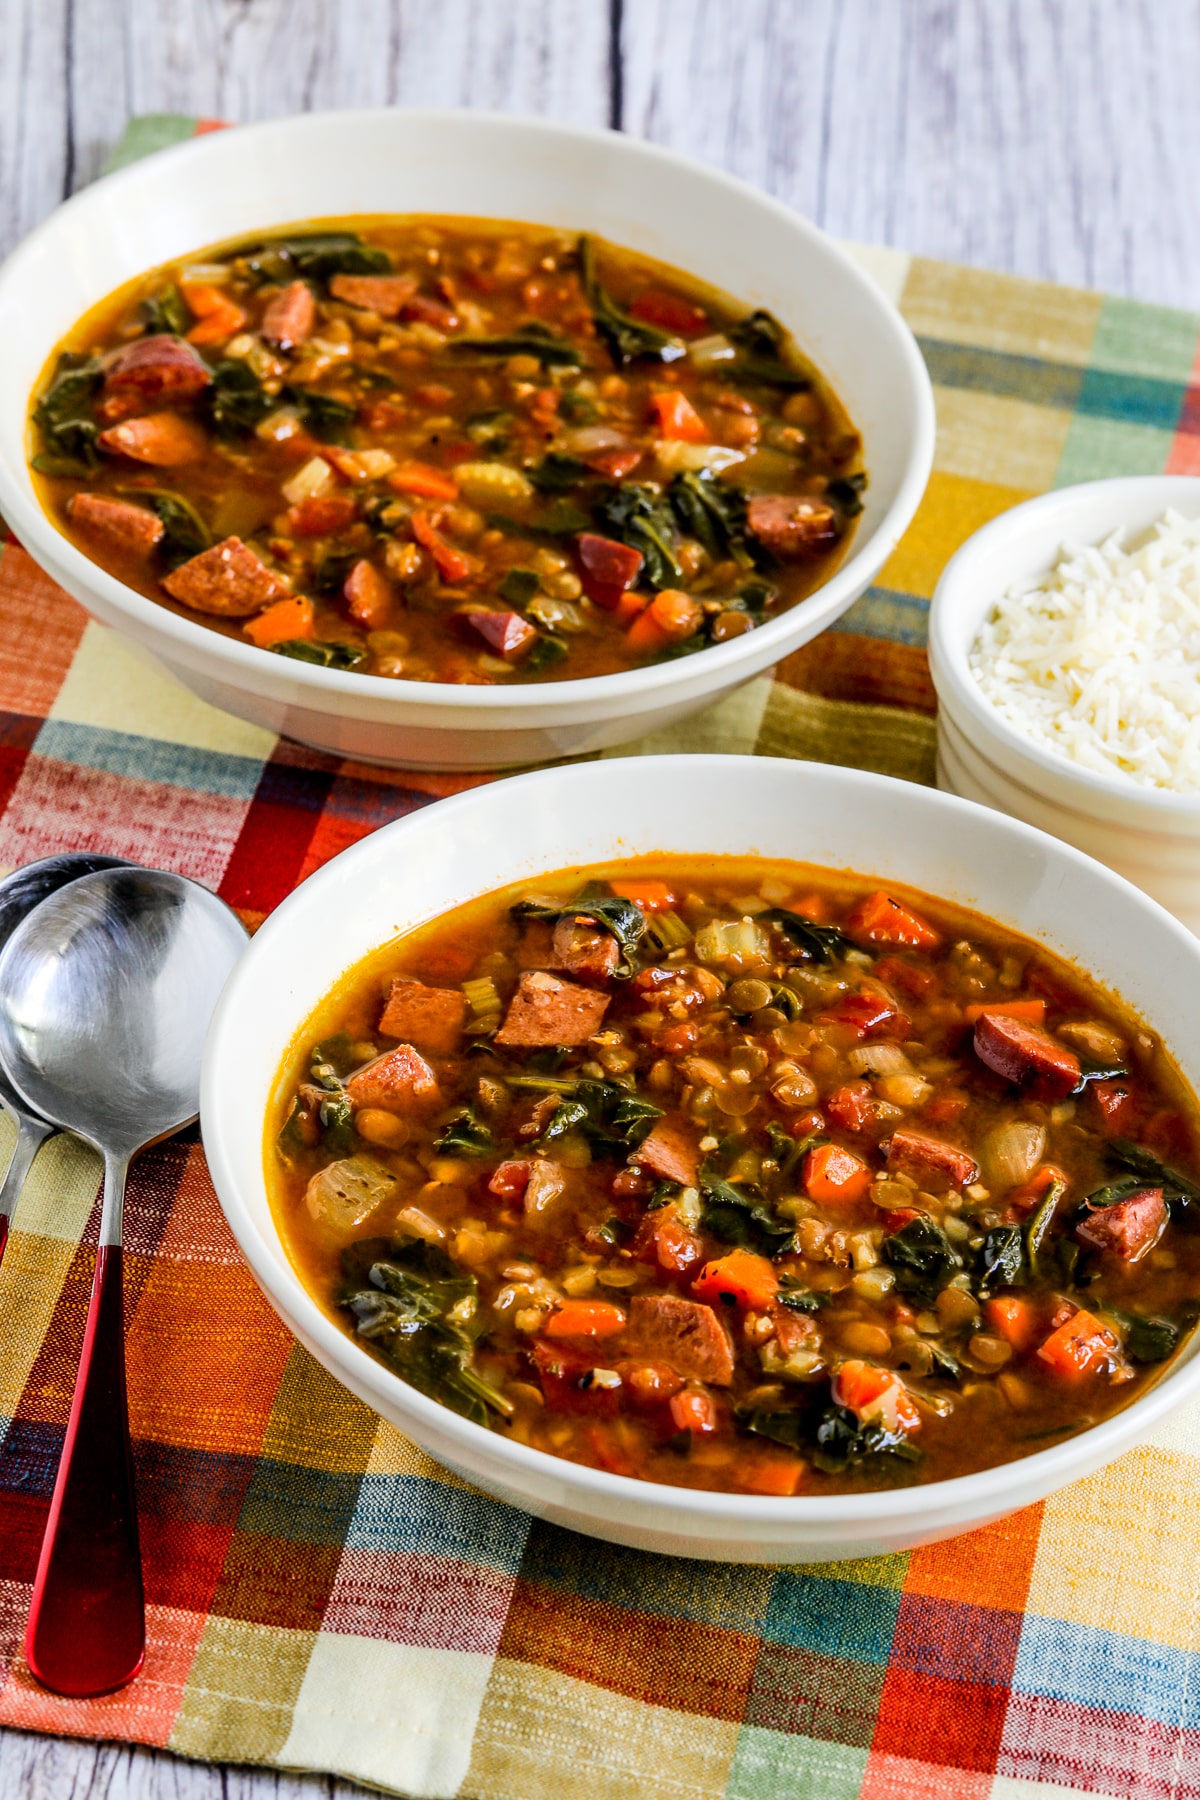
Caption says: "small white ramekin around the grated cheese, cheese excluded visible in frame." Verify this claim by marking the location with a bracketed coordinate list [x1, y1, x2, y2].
[928, 475, 1200, 931]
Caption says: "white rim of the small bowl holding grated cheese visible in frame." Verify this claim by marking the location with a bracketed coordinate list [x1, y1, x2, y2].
[928, 473, 1200, 823]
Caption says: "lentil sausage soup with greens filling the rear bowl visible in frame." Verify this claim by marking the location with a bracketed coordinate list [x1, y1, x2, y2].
[31, 218, 867, 684]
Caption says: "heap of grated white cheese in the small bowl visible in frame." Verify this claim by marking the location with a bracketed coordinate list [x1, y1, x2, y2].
[970, 511, 1200, 794]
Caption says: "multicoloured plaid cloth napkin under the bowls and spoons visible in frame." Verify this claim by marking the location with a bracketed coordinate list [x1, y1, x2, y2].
[0, 119, 1200, 1800]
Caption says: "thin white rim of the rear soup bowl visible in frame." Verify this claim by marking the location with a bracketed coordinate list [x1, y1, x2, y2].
[0, 106, 936, 727]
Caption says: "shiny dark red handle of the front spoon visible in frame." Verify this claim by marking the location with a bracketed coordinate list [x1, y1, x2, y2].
[25, 1244, 146, 1697]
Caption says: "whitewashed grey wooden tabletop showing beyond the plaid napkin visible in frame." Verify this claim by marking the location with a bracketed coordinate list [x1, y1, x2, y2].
[0, 0, 1200, 1800]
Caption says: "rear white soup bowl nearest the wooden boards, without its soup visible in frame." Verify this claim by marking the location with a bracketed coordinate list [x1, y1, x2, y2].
[0, 110, 934, 769]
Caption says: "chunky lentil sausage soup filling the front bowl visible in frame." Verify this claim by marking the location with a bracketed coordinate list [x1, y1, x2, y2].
[266, 859, 1200, 1494]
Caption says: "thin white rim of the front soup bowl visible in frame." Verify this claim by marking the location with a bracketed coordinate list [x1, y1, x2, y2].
[200, 754, 1200, 1534]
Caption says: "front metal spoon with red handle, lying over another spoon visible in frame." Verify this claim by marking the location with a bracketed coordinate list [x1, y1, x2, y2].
[0, 868, 246, 1697]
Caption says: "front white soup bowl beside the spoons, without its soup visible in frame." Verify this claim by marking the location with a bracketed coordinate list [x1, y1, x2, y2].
[201, 756, 1200, 1562]
